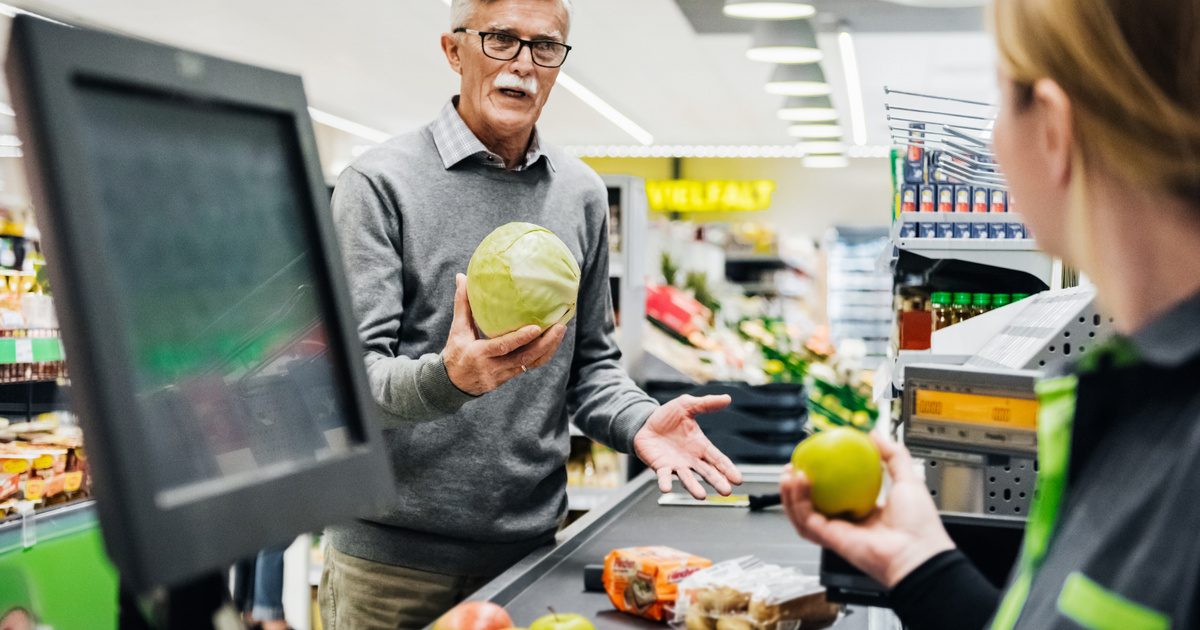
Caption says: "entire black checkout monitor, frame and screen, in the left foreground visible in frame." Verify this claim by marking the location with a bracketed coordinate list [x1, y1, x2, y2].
[7, 18, 390, 588]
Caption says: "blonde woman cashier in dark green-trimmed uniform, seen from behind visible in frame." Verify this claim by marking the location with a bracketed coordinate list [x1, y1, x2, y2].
[782, 0, 1200, 630]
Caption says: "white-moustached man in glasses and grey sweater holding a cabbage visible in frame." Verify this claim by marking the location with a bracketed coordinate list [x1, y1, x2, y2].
[320, 0, 742, 630]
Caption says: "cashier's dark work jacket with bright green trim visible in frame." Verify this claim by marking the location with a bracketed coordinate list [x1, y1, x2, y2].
[890, 295, 1200, 630]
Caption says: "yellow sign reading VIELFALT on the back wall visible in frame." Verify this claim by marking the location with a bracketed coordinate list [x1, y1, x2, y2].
[646, 179, 775, 212]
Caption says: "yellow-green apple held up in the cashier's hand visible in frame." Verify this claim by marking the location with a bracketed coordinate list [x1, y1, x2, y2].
[792, 427, 883, 520]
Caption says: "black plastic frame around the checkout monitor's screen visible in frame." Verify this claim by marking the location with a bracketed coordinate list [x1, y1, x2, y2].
[6, 16, 394, 590]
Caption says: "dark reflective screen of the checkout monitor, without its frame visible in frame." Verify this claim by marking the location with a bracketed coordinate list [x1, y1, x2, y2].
[78, 84, 355, 506]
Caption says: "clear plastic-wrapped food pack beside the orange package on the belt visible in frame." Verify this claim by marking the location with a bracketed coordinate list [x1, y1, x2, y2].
[673, 556, 841, 630]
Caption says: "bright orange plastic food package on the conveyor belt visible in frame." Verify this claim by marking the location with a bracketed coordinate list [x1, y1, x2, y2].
[604, 547, 713, 622]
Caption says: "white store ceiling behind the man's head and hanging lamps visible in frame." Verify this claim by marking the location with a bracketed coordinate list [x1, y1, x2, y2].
[13, 0, 995, 145]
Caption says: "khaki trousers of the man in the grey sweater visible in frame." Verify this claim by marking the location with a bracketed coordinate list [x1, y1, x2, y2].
[317, 547, 488, 630]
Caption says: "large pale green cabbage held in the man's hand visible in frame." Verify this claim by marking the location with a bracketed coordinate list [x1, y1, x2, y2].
[467, 223, 580, 337]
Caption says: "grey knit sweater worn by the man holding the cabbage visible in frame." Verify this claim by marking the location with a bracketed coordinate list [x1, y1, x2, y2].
[329, 105, 655, 576]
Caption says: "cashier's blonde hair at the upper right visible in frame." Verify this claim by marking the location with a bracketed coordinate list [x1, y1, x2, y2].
[991, 0, 1200, 204]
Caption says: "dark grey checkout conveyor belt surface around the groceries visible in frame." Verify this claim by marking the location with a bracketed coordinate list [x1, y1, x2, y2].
[469, 466, 899, 630]
